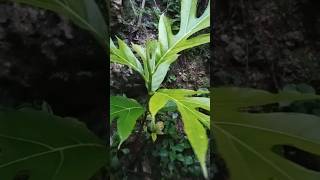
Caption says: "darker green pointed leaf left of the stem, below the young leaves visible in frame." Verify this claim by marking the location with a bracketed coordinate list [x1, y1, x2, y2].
[110, 96, 144, 148]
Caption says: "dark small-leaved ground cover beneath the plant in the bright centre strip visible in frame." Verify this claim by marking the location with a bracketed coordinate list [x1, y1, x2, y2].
[111, 108, 202, 179]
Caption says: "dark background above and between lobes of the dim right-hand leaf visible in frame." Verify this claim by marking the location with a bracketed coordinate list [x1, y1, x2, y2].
[210, 0, 320, 180]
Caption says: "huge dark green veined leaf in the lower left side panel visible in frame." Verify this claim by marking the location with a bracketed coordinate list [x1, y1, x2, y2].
[0, 109, 107, 180]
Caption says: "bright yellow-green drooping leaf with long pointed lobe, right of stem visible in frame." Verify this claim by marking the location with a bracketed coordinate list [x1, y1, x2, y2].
[149, 89, 210, 177]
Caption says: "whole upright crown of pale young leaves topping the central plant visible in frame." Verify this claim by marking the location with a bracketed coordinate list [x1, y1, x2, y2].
[110, 0, 210, 92]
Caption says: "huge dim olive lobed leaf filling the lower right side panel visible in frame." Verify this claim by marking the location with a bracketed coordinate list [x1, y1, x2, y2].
[212, 88, 320, 180]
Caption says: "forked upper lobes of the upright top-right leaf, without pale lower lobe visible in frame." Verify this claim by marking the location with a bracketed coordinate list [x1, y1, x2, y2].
[157, 0, 210, 65]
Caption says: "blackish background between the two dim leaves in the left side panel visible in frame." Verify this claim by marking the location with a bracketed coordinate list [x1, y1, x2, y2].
[0, 1, 109, 179]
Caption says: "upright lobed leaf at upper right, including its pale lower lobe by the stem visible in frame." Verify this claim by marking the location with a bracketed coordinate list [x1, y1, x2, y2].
[151, 0, 210, 92]
